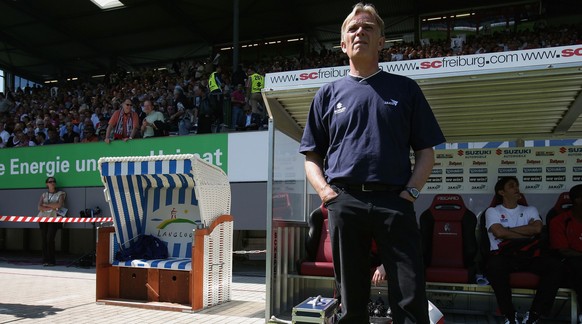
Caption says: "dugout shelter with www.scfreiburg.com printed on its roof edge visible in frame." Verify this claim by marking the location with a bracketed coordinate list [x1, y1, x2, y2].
[262, 45, 582, 318]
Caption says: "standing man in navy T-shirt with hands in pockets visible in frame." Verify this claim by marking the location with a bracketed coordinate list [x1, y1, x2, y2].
[300, 3, 445, 324]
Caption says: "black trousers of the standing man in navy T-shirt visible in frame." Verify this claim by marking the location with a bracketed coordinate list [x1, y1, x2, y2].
[326, 185, 429, 324]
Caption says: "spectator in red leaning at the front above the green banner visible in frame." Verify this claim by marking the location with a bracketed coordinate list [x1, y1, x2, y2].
[105, 98, 139, 144]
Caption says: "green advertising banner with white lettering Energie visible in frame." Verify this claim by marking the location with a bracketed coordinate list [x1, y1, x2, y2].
[0, 134, 228, 189]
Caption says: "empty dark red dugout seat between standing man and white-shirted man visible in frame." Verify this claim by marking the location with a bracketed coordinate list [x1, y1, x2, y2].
[419, 194, 478, 283]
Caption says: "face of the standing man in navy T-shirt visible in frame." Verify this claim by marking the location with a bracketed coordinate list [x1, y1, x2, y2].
[341, 12, 384, 59]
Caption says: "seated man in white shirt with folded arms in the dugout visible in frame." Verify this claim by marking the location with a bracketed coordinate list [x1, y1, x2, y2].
[485, 177, 562, 324]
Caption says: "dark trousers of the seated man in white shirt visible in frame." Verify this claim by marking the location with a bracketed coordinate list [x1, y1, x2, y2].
[487, 254, 564, 316]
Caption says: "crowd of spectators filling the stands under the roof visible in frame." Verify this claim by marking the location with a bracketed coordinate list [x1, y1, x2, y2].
[0, 24, 582, 148]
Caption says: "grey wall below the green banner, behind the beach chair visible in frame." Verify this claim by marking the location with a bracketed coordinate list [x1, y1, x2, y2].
[0, 182, 267, 254]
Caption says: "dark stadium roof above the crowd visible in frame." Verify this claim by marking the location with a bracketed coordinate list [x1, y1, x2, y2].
[0, 0, 552, 82]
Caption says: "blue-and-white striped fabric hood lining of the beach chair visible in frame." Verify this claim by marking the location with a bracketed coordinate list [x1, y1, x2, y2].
[99, 155, 198, 258]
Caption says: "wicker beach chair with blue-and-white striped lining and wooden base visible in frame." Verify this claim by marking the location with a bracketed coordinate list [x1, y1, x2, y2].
[97, 154, 233, 310]
